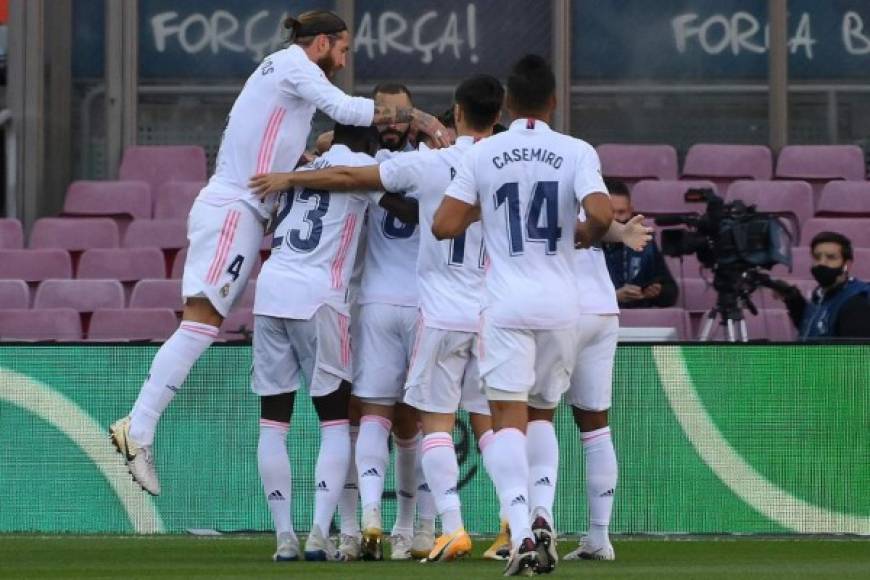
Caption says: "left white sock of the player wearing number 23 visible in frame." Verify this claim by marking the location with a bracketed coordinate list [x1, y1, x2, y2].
[257, 419, 294, 536]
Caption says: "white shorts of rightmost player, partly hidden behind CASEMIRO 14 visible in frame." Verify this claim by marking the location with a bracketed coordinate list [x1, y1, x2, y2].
[565, 314, 619, 411]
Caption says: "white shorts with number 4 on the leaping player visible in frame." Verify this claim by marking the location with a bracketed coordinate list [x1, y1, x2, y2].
[181, 201, 263, 318]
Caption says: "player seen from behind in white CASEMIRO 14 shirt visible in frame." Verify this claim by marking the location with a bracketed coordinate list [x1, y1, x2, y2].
[432, 55, 612, 575]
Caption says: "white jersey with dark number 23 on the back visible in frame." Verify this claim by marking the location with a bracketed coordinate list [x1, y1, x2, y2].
[254, 145, 383, 320]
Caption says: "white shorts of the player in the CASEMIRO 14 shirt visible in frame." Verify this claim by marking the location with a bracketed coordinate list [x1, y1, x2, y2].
[478, 321, 577, 409]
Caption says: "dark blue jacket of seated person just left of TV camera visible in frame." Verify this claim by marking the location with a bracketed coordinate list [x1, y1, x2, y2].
[604, 241, 679, 308]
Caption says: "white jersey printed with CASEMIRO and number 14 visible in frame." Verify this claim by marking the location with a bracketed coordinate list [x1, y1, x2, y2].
[447, 119, 607, 329]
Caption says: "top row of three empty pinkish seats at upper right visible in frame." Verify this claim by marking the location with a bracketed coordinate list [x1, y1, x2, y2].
[597, 143, 867, 185]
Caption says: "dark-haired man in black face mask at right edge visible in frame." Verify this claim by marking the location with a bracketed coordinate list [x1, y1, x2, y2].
[775, 232, 870, 340]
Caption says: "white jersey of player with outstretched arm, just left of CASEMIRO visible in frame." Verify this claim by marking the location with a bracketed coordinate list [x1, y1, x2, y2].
[380, 137, 485, 332]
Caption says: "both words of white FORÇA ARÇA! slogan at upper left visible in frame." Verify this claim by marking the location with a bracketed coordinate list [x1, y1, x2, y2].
[150, 3, 480, 64]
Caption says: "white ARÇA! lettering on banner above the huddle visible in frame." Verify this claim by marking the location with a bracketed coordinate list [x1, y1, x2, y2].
[353, 3, 480, 64]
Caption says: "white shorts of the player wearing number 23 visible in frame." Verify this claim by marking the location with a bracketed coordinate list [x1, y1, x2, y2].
[251, 306, 351, 397]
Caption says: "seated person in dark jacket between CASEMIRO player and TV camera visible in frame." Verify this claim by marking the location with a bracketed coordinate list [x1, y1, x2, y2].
[603, 179, 679, 308]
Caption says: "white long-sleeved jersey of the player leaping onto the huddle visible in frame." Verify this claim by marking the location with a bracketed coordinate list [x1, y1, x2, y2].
[199, 45, 374, 207]
